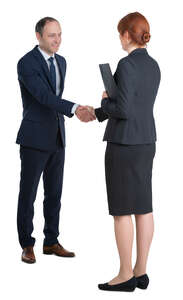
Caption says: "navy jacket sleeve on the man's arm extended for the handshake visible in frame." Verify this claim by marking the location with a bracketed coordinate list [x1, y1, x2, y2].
[17, 59, 75, 117]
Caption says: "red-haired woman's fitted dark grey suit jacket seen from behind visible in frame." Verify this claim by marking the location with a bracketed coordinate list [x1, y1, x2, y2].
[95, 48, 161, 145]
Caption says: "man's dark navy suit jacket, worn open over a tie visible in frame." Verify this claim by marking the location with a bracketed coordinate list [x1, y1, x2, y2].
[16, 45, 75, 150]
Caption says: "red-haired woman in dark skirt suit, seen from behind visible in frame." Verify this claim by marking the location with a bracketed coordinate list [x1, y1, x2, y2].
[95, 12, 160, 291]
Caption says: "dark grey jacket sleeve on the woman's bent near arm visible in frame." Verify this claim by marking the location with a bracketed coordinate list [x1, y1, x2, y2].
[101, 60, 133, 119]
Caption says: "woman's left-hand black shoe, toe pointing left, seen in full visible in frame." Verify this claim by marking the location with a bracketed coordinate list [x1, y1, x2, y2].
[98, 276, 137, 292]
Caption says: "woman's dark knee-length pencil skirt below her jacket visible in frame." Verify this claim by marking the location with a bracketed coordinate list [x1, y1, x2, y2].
[105, 142, 156, 216]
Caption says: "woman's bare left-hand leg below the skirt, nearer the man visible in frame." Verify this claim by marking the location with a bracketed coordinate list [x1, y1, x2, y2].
[109, 215, 134, 284]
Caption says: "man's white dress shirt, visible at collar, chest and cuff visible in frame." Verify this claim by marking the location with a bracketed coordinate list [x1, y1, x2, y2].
[38, 46, 79, 114]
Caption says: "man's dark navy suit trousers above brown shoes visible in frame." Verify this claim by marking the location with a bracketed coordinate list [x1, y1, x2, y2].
[17, 131, 65, 248]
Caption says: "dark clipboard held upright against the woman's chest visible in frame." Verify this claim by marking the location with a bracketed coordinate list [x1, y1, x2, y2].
[99, 63, 118, 100]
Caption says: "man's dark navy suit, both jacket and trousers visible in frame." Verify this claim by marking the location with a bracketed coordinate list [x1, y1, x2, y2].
[16, 45, 75, 248]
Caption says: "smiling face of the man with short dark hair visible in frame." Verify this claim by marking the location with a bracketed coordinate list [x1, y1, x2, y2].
[36, 21, 62, 55]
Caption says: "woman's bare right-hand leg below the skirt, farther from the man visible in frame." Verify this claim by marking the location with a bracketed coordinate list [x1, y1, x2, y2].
[133, 213, 154, 277]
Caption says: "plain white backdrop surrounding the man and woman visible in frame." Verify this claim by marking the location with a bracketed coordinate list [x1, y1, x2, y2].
[0, 0, 183, 300]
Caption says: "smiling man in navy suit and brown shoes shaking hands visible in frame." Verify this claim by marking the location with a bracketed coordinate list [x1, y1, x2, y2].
[16, 17, 96, 263]
